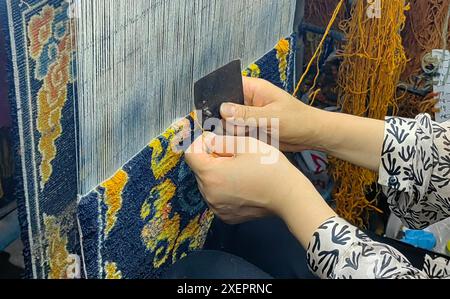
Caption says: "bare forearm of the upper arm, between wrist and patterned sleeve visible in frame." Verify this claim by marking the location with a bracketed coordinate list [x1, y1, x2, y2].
[300, 108, 385, 171]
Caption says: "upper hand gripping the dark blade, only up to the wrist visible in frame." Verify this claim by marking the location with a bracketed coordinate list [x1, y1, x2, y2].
[221, 77, 315, 152]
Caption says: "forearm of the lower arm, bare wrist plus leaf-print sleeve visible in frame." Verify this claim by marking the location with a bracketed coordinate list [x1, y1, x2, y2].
[280, 179, 428, 279]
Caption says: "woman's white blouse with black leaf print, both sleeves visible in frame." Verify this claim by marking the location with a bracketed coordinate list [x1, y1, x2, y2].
[307, 114, 450, 279]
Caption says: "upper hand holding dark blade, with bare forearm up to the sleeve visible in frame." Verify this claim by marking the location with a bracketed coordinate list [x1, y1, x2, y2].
[221, 78, 385, 171]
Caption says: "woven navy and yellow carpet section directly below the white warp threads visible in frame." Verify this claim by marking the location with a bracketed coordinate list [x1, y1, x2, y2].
[79, 36, 295, 278]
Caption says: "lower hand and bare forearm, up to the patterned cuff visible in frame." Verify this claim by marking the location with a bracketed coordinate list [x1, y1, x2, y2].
[186, 133, 335, 246]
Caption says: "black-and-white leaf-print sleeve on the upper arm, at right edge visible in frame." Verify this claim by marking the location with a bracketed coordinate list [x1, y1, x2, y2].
[379, 114, 450, 229]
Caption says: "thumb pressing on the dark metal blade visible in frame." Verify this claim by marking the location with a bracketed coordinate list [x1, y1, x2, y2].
[220, 103, 266, 124]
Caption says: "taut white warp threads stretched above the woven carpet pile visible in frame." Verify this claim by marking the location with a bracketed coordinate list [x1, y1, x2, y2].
[75, 0, 296, 194]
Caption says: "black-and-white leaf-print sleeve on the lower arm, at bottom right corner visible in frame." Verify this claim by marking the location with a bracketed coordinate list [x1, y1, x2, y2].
[307, 217, 450, 279]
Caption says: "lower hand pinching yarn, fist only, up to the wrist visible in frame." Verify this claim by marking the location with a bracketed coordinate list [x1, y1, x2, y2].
[186, 133, 307, 224]
